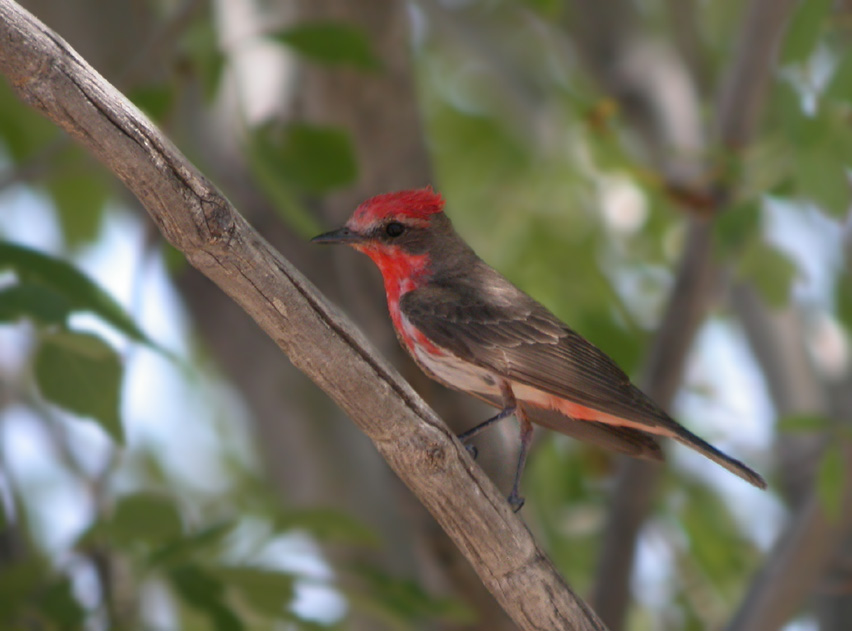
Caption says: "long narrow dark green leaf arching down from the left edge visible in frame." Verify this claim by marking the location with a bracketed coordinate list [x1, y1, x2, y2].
[0, 241, 157, 348]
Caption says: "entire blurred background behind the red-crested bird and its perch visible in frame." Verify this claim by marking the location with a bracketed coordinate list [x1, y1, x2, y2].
[0, 0, 852, 631]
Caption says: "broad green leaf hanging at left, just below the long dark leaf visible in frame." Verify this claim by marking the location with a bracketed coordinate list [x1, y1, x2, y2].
[35, 331, 124, 443]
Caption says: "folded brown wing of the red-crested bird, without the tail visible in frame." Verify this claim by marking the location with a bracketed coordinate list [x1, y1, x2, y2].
[400, 276, 676, 432]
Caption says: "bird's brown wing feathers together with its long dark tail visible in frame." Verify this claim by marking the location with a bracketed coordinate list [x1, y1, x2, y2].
[400, 270, 766, 488]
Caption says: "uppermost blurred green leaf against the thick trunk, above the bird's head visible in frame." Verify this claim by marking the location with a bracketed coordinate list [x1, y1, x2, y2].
[272, 21, 381, 70]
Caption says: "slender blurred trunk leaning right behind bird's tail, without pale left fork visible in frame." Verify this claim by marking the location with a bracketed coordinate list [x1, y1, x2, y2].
[582, 0, 796, 629]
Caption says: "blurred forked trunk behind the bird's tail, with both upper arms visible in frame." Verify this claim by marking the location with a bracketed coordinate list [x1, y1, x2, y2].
[576, 0, 795, 629]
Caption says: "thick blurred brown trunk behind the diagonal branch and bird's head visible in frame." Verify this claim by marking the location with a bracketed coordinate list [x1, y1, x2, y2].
[180, 0, 515, 631]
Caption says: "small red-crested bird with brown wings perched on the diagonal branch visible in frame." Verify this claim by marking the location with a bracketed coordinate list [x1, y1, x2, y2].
[312, 188, 766, 511]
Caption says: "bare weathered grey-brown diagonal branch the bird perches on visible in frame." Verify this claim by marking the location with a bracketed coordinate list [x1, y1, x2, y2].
[0, 0, 605, 631]
